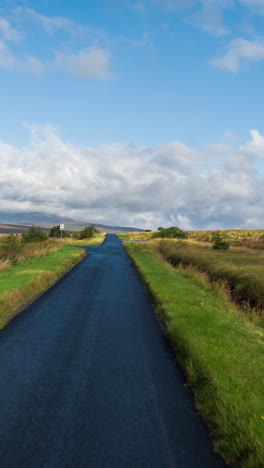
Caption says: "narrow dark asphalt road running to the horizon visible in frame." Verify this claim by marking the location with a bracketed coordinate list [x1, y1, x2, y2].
[0, 235, 225, 468]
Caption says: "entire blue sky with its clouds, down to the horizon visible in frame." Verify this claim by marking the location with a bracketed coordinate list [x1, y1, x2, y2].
[0, 0, 264, 228]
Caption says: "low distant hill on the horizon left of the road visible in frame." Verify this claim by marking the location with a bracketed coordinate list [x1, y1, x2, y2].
[0, 212, 144, 233]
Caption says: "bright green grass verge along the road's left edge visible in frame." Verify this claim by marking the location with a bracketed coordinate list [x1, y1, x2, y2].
[0, 246, 86, 328]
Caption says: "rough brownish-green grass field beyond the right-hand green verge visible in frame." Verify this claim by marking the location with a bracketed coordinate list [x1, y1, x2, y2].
[157, 240, 264, 324]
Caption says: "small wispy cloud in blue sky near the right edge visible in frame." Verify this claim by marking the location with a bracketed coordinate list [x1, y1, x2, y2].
[211, 37, 264, 73]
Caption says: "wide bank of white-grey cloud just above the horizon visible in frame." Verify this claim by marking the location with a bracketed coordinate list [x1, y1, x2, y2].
[0, 126, 264, 229]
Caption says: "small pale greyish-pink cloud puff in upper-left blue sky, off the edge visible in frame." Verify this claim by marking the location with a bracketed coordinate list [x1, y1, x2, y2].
[55, 47, 110, 79]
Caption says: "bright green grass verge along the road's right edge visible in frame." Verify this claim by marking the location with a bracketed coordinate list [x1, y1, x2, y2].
[125, 243, 264, 468]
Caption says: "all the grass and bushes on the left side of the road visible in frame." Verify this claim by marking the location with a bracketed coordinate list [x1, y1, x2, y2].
[0, 226, 104, 328]
